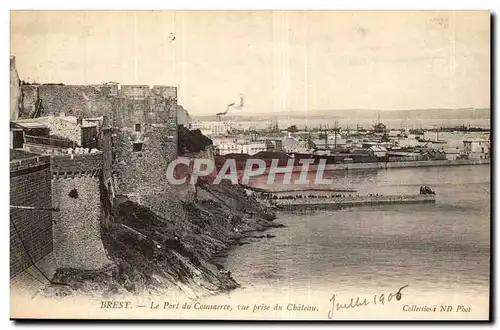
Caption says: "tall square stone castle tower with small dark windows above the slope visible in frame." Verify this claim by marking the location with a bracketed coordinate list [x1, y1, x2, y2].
[112, 85, 182, 215]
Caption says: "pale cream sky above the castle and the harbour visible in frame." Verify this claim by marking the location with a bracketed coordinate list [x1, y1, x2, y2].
[10, 11, 490, 115]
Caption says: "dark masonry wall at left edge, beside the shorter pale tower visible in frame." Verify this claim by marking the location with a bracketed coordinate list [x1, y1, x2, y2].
[10, 156, 52, 278]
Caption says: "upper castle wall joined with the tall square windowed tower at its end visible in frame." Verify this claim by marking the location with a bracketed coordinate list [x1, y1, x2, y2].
[21, 84, 178, 195]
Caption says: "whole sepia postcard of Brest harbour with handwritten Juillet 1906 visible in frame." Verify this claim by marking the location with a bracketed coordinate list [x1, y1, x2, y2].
[10, 10, 492, 321]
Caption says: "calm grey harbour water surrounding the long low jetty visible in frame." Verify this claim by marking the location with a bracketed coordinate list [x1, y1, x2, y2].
[221, 165, 490, 318]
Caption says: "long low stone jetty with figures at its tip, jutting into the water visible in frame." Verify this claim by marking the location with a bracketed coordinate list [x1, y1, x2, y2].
[271, 194, 436, 210]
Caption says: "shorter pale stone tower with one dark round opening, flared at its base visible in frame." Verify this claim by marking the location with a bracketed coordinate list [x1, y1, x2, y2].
[51, 152, 111, 269]
